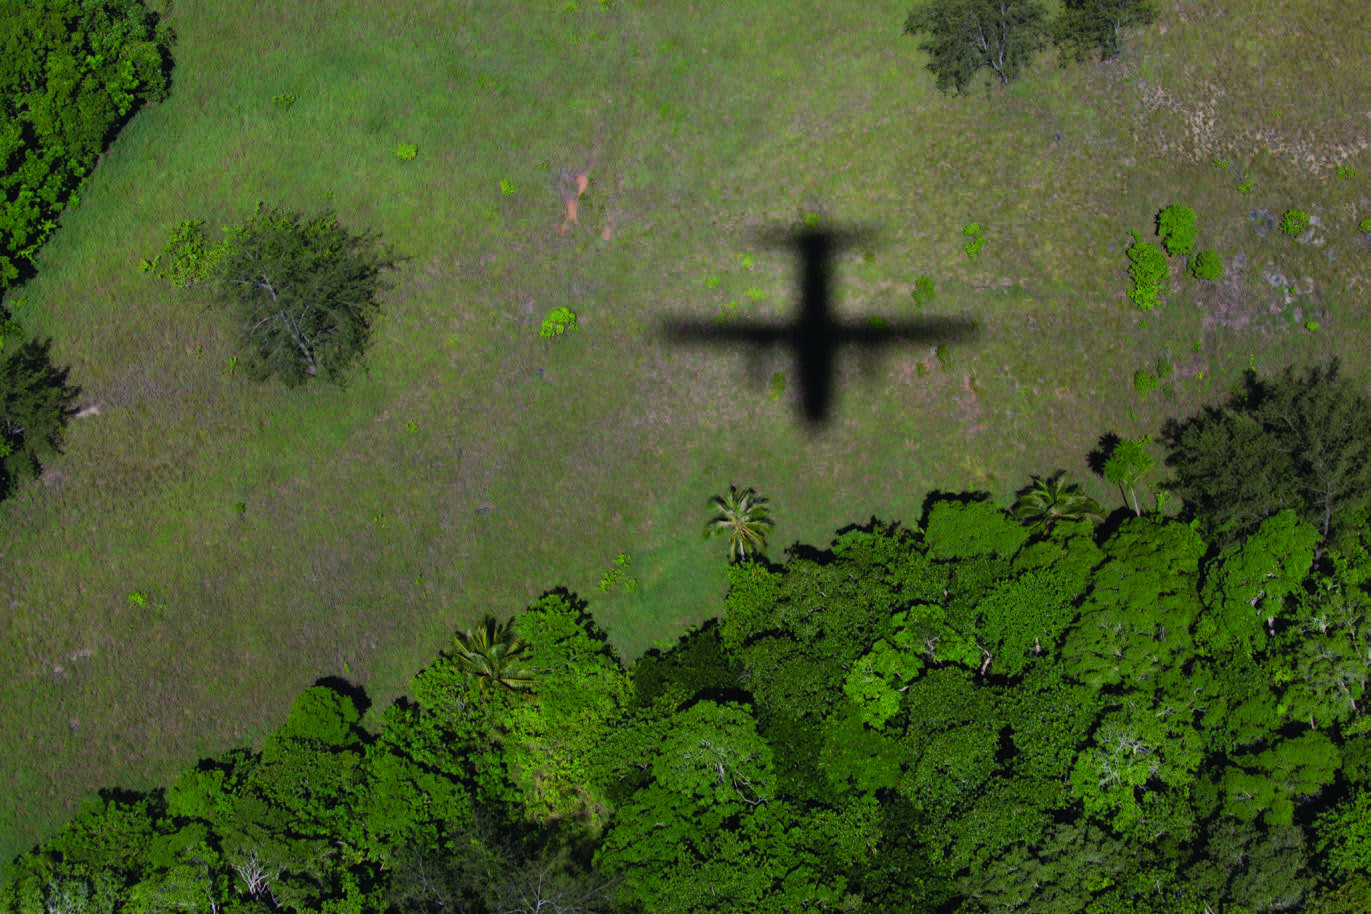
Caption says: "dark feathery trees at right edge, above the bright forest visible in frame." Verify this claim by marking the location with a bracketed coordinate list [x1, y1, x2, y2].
[1163, 362, 1371, 543]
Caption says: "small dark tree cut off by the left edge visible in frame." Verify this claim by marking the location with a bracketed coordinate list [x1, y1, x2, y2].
[0, 340, 80, 497]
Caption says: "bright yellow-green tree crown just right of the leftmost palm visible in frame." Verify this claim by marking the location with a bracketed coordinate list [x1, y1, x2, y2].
[503, 592, 629, 818]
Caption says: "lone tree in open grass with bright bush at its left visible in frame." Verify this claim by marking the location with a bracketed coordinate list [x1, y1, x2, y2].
[143, 203, 400, 386]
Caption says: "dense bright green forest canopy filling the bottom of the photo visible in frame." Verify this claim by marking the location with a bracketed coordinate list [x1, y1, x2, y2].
[8, 460, 1371, 914]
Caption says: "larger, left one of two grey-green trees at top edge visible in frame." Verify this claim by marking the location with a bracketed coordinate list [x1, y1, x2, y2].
[905, 0, 1049, 95]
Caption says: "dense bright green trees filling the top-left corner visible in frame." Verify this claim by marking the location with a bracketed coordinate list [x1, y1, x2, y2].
[0, 0, 174, 291]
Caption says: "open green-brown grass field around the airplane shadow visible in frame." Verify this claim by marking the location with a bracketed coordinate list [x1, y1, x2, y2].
[0, 0, 1371, 861]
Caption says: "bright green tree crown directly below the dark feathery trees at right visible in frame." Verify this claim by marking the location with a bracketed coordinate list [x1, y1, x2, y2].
[1196, 510, 1319, 652]
